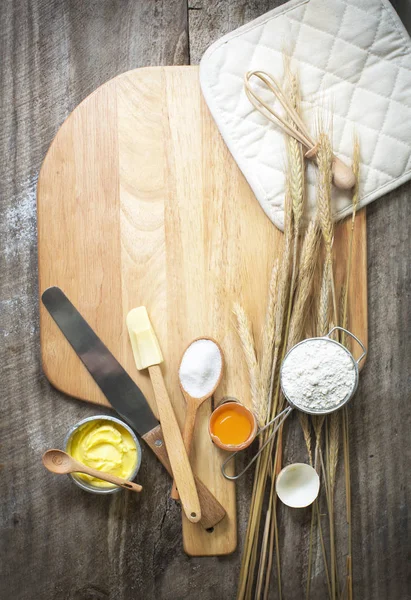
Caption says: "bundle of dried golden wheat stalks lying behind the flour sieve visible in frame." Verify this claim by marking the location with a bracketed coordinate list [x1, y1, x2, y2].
[237, 62, 366, 600]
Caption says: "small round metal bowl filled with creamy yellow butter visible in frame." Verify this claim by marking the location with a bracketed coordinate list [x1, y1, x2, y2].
[64, 415, 141, 494]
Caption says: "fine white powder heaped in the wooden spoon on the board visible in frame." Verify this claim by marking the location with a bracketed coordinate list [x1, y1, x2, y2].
[179, 339, 223, 398]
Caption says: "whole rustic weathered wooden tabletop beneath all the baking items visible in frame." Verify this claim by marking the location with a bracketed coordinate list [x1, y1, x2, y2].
[0, 0, 411, 600]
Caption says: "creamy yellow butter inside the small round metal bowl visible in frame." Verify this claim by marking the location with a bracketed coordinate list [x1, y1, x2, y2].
[68, 419, 138, 488]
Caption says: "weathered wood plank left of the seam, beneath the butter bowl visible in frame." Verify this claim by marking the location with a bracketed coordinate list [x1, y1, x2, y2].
[0, 0, 195, 600]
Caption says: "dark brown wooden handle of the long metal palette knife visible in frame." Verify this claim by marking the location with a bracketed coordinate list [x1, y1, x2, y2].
[143, 425, 226, 529]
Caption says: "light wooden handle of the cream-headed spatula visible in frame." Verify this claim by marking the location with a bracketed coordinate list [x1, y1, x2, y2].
[148, 365, 201, 523]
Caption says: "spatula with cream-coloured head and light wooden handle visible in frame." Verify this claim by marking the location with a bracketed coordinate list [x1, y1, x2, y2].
[127, 306, 201, 523]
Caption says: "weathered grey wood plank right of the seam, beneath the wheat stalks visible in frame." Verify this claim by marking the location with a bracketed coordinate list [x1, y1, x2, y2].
[189, 0, 411, 600]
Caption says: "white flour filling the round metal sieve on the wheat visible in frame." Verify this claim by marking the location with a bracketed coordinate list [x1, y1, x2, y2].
[281, 339, 356, 410]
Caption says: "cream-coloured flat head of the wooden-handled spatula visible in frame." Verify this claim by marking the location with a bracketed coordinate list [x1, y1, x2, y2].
[126, 306, 163, 371]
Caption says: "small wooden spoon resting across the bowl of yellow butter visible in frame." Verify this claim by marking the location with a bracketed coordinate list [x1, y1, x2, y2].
[42, 450, 143, 492]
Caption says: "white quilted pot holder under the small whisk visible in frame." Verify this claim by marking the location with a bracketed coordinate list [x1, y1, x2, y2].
[200, 0, 411, 229]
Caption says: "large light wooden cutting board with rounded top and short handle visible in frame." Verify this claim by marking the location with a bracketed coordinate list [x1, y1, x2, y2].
[37, 67, 367, 555]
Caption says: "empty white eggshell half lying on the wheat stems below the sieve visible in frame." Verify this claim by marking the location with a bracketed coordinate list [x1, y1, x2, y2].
[275, 463, 320, 508]
